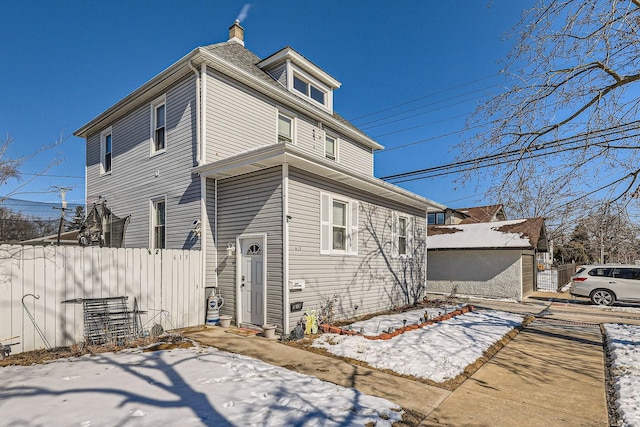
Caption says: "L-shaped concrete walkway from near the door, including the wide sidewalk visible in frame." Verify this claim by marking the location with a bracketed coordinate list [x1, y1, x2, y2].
[187, 301, 608, 426]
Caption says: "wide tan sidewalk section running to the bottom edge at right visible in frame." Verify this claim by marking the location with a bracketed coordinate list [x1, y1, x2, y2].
[420, 321, 608, 426]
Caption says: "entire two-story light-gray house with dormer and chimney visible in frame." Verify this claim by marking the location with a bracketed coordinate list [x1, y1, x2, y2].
[75, 23, 445, 331]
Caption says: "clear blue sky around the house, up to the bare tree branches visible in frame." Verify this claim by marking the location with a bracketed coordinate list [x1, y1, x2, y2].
[0, 0, 532, 211]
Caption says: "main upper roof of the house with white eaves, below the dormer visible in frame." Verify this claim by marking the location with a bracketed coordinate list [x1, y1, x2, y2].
[73, 41, 384, 150]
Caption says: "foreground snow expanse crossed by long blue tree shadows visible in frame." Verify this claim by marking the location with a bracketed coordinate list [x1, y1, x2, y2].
[0, 347, 401, 427]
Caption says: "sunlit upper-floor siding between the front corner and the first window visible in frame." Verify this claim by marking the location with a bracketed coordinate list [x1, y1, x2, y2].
[206, 71, 277, 163]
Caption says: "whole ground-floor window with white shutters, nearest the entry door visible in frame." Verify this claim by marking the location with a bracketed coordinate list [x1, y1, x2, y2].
[320, 193, 358, 255]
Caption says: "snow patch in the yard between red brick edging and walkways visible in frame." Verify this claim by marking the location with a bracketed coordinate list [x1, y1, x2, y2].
[313, 310, 523, 382]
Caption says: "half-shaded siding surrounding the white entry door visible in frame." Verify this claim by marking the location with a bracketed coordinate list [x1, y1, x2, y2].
[217, 167, 283, 328]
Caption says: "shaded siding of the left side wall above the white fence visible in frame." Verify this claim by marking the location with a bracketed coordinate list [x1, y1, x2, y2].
[87, 76, 200, 249]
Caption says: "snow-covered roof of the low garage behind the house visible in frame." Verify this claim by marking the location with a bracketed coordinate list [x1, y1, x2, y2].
[427, 218, 548, 252]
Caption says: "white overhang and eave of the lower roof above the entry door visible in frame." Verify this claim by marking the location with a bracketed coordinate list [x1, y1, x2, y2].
[193, 143, 446, 212]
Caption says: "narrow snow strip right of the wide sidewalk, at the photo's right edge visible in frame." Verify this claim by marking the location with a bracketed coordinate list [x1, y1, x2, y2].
[604, 324, 640, 426]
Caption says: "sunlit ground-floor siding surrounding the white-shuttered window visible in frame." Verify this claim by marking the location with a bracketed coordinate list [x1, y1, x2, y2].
[289, 168, 425, 330]
